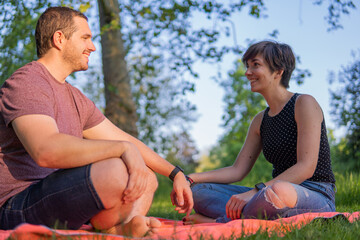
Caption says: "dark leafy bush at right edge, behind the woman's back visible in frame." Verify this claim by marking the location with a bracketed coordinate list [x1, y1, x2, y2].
[329, 51, 360, 170]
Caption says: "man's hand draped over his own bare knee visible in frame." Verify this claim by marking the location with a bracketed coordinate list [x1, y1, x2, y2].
[121, 142, 149, 203]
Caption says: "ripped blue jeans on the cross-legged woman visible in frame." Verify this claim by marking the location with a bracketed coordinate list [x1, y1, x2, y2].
[191, 180, 335, 223]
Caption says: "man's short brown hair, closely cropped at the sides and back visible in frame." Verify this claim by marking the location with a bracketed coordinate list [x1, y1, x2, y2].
[35, 7, 87, 58]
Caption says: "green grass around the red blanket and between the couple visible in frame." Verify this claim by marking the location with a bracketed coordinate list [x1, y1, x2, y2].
[148, 170, 360, 240]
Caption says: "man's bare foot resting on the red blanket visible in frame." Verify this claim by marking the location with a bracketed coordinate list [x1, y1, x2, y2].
[106, 215, 161, 237]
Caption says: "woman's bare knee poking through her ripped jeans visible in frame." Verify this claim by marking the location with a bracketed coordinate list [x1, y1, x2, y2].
[265, 181, 297, 209]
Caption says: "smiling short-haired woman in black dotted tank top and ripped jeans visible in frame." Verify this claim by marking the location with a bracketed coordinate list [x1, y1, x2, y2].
[183, 41, 335, 224]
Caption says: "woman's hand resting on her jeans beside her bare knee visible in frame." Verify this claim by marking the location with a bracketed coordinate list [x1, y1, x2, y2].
[226, 189, 257, 220]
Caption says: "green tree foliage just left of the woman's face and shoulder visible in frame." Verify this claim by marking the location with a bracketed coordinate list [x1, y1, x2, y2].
[202, 61, 266, 167]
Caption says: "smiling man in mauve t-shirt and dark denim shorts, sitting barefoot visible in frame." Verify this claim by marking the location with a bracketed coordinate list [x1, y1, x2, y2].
[0, 7, 193, 236]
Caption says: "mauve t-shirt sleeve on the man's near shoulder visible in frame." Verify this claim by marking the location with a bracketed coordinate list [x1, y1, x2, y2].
[0, 70, 55, 126]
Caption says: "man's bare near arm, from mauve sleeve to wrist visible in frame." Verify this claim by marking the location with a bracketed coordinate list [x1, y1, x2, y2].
[12, 115, 138, 168]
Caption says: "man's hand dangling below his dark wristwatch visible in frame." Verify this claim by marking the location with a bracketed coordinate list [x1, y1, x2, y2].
[170, 173, 194, 216]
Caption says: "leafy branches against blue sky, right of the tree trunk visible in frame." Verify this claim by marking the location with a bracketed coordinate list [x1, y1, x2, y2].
[109, 0, 263, 149]
